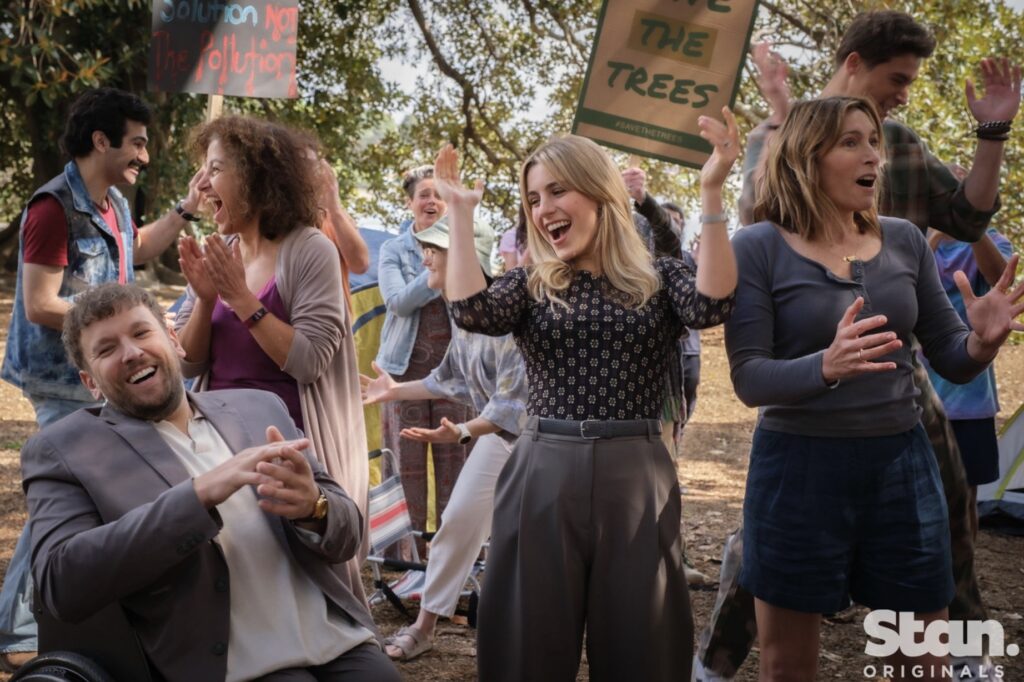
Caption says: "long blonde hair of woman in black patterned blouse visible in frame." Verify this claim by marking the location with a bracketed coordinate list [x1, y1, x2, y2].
[519, 135, 662, 308]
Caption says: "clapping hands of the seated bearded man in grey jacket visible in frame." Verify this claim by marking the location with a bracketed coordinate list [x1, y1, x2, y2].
[193, 426, 319, 519]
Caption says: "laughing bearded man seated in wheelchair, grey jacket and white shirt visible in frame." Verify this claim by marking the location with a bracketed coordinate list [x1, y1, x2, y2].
[22, 284, 398, 682]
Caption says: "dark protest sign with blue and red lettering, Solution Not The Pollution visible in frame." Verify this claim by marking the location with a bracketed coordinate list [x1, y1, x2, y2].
[148, 0, 299, 98]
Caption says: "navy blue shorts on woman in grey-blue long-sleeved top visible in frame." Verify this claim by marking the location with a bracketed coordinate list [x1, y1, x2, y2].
[739, 424, 953, 613]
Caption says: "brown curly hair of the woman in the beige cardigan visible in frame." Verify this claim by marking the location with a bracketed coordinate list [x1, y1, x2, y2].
[190, 116, 319, 241]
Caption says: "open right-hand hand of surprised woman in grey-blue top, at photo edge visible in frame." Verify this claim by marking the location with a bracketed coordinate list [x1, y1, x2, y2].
[953, 254, 1024, 361]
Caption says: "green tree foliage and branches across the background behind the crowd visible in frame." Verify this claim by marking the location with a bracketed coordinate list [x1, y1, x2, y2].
[0, 0, 1024, 251]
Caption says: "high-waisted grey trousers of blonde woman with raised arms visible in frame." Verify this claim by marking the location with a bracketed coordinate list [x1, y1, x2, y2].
[477, 417, 693, 682]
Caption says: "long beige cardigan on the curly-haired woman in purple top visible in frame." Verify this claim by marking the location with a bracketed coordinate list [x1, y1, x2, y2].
[174, 227, 370, 601]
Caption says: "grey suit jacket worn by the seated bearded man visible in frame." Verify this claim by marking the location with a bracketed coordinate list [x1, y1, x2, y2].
[22, 389, 376, 680]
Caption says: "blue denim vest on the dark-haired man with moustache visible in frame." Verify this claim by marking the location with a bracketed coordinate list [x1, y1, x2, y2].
[0, 161, 134, 401]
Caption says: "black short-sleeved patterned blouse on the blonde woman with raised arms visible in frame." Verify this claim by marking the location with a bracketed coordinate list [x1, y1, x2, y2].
[451, 258, 734, 420]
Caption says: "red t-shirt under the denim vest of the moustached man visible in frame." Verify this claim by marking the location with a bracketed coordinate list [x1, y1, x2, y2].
[22, 195, 138, 284]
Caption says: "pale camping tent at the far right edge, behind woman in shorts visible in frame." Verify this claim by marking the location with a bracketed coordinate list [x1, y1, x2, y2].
[978, 404, 1024, 535]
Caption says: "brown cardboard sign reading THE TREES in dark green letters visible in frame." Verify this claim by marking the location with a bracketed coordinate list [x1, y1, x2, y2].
[572, 0, 757, 168]
